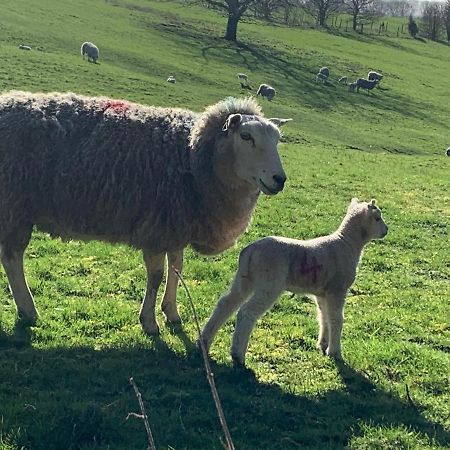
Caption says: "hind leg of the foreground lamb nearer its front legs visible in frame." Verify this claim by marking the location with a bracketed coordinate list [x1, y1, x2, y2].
[230, 287, 281, 366]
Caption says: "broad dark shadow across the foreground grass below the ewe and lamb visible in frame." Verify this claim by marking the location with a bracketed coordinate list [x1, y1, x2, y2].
[0, 325, 450, 450]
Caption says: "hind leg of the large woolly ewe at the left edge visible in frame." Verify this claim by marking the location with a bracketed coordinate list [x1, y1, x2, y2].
[1, 229, 39, 325]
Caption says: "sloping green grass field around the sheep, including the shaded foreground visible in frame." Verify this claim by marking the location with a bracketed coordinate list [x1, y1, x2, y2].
[0, 0, 450, 450]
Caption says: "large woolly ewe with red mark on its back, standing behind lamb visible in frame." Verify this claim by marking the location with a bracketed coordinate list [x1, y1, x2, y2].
[0, 92, 286, 334]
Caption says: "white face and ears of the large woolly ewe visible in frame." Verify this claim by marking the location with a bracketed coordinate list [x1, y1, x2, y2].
[221, 114, 290, 195]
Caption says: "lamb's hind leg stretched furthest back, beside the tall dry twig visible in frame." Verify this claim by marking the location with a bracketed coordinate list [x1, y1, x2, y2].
[201, 271, 251, 352]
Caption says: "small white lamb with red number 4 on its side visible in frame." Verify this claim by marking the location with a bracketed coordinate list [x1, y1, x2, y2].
[200, 198, 388, 366]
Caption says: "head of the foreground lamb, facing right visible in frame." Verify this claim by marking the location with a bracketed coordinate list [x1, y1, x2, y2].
[348, 198, 388, 242]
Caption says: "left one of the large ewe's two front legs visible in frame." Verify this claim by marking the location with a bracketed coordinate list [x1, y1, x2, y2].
[139, 250, 166, 334]
